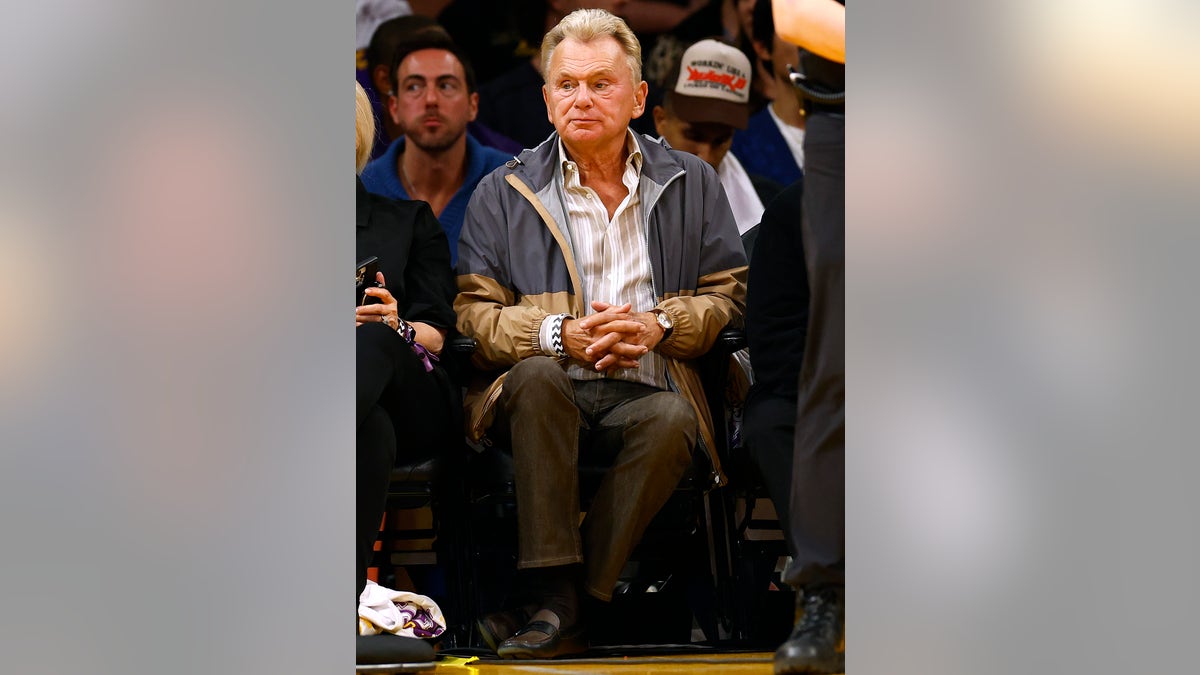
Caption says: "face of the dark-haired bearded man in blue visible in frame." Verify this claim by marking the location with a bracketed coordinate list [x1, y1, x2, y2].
[389, 49, 479, 153]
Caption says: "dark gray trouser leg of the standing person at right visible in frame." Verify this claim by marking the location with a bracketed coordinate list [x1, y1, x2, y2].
[785, 114, 846, 585]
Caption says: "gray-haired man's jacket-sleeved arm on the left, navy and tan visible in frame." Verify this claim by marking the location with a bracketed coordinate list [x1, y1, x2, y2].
[454, 173, 547, 370]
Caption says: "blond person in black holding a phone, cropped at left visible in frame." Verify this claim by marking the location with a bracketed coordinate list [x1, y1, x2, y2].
[355, 78, 460, 593]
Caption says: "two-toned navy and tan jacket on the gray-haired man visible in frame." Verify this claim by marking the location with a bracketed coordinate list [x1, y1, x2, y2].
[455, 135, 746, 486]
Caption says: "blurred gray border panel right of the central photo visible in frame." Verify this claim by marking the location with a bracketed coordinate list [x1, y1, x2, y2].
[846, 0, 1200, 675]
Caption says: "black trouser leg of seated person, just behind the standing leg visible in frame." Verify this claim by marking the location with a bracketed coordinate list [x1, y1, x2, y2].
[742, 394, 798, 558]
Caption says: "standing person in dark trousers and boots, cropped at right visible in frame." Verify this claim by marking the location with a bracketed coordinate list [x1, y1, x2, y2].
[751, 0, 846, 675]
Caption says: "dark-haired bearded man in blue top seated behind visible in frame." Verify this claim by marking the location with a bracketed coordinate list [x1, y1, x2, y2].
[362, 35, 510, 267]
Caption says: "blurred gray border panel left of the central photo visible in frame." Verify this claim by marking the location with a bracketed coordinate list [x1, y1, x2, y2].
[0, 1, 354, 674]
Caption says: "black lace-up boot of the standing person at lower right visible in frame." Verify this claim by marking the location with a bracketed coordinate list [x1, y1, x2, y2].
[775, 585, 846, 675]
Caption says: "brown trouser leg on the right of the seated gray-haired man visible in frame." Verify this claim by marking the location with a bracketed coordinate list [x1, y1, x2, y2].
[576, 381, 698, 601]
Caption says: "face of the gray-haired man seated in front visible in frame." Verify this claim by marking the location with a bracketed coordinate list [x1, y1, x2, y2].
[541, 36, 646, 150]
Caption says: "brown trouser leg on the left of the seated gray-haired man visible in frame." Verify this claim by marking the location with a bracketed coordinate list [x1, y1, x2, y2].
[497, 357, 583, 569]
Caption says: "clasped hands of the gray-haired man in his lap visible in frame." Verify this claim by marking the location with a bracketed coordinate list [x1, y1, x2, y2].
[563, 301, 662, 372]
